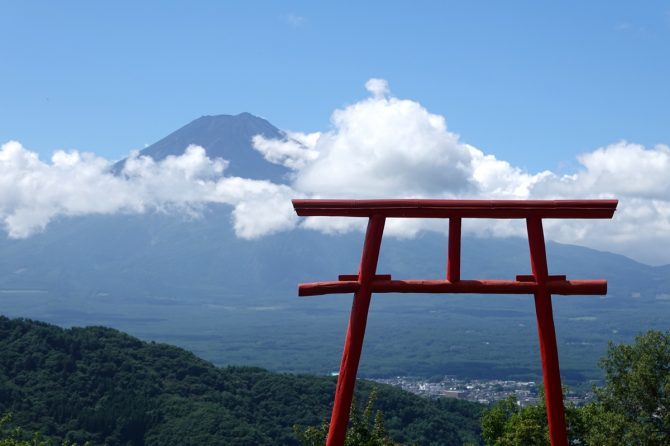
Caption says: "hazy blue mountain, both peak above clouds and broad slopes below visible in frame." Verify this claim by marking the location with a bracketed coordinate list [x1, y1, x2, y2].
[0, 113, 670, 380]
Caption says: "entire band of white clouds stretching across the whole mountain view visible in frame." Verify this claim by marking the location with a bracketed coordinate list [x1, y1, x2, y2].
[0, 79, 670, 263]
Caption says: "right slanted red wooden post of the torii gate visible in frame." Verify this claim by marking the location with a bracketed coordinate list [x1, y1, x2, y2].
[526, 218, 568, 446]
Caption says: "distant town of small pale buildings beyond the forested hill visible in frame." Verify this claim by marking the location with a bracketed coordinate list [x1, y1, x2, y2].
[370, 376, 593, 407]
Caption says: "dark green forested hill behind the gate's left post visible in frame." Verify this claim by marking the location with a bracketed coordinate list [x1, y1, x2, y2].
[0, 316, 480, 446]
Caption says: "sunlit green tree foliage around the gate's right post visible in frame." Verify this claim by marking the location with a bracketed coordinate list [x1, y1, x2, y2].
[482, 331, 670, 446]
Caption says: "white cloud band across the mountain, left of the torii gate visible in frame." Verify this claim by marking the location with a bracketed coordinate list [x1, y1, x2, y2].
[0, 141, 296, 238]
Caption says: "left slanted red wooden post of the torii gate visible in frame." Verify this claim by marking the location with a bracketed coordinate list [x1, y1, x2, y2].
[326, 217, 384, 446]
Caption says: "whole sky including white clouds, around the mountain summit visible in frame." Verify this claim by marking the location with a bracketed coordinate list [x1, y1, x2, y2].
[0, 0, 670, 264]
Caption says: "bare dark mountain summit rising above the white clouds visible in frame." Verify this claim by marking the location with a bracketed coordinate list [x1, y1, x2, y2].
[115, 113, 287, 183]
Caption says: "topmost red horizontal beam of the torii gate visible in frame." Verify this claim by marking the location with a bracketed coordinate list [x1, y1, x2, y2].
[293, 199, 618, 218]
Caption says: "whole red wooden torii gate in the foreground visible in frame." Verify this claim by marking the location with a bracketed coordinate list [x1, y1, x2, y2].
[293, 199, 618, 446]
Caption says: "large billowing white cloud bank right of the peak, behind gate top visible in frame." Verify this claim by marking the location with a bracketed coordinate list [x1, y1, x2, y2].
[253, 79, 670, 263]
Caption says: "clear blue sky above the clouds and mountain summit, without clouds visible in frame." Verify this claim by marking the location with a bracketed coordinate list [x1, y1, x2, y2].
[0, 1, 670, 173]
